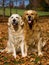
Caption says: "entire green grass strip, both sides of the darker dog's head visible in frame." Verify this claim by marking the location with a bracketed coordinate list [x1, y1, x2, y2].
[0, 8, 49, 16]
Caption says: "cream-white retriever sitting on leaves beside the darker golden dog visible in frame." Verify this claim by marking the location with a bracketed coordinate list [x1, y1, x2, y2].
[0, 14, 27, 58]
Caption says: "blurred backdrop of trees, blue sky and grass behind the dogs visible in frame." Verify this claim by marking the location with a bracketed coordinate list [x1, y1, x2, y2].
[0, 0, 49, 16]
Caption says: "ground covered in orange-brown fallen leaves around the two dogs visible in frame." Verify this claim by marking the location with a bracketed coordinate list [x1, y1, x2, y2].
[0, 17, 49, 65]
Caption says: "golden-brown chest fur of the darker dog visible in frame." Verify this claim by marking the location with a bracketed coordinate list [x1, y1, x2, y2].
[24, 24, 39, 45]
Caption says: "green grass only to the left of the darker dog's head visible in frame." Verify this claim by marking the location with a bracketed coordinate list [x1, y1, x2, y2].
[0, 8, 24, 16]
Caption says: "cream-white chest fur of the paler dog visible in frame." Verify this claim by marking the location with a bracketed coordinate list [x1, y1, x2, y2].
[9, 27, 23, 48]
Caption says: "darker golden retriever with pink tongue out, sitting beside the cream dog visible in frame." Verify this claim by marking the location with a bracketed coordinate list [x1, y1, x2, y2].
[22, 10, 46, 56]
